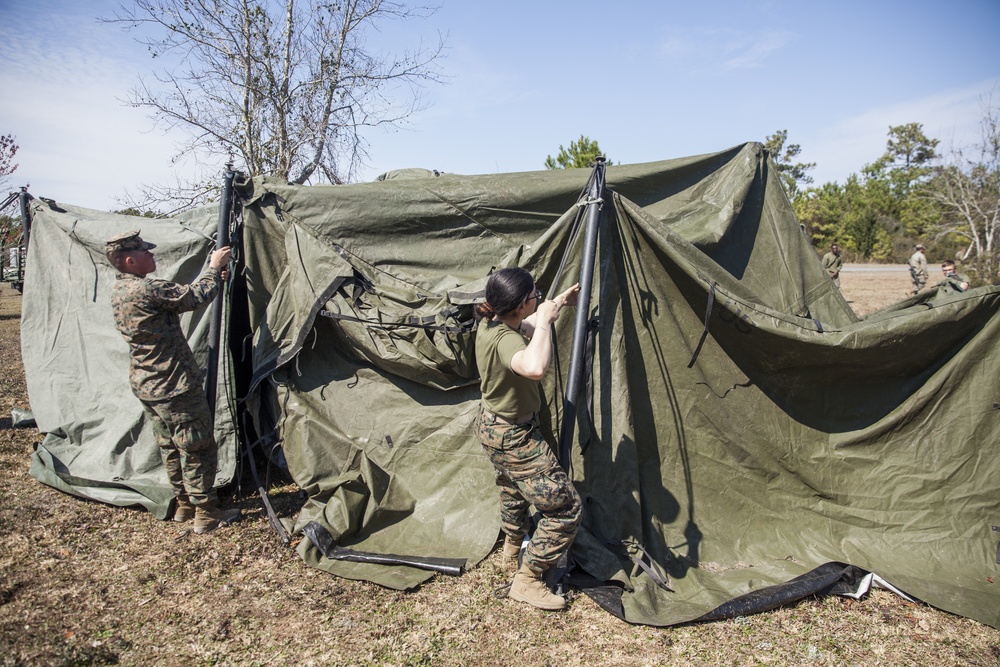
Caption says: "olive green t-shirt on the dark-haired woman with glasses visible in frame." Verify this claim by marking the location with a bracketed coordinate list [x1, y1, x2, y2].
[476, 318, 542, 419]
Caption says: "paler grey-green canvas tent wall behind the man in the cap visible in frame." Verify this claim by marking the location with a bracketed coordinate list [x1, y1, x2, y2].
[21, 205, 236, 519]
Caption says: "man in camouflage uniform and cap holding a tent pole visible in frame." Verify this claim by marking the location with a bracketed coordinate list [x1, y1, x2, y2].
[105, 231, 240, 533]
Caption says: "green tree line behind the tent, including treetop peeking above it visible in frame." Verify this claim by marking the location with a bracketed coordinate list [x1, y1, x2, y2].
[545, 109, 1000, 284]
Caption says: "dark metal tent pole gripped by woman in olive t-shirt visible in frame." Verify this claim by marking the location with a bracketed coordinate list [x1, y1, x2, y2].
[559, 157, 604, 473]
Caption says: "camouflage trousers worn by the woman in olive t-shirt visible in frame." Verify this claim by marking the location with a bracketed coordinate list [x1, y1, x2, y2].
[477, 404, 583, 574]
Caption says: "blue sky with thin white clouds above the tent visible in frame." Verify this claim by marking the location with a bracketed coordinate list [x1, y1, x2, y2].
[0, 0, 1000, 209]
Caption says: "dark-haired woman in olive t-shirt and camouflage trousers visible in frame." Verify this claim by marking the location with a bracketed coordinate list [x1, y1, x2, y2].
[476, 268, 582, 610]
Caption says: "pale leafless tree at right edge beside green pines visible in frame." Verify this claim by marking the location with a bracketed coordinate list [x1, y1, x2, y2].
[926, 95, 1000, 282]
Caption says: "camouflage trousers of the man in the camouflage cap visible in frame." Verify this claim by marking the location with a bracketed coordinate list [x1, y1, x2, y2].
[142, 390, 219, 505]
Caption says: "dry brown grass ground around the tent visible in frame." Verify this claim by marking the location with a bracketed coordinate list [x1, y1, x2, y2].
[0, 273, 1000, 666]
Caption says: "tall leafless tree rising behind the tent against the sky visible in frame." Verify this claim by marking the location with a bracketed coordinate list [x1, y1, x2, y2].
[105, 0, 443, 208]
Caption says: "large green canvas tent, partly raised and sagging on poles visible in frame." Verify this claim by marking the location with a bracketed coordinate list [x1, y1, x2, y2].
[23, 144, 1000, 627]
